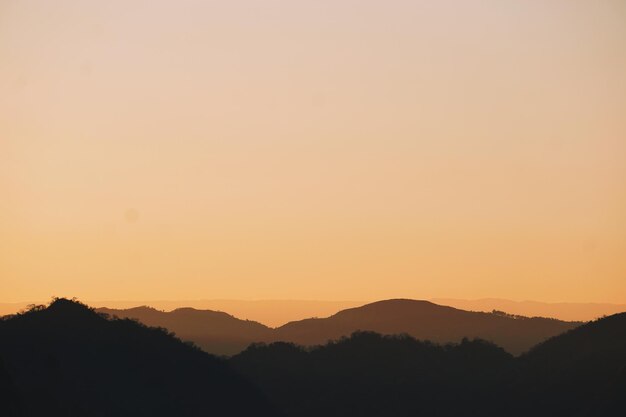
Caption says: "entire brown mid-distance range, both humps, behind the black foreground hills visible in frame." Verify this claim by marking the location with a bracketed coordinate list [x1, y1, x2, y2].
[98, 299, 580, 355]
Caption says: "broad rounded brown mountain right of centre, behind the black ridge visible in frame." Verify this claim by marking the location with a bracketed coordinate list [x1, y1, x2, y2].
[274, 299, 580, 354]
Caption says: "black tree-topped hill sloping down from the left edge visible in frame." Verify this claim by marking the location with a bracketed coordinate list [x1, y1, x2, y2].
[0, 299, 277, 417]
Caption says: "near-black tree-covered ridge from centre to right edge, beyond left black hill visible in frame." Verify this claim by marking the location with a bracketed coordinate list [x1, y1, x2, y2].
[231, 313, 626, 417]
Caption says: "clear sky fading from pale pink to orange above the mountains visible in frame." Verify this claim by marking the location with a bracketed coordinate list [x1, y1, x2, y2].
[0, 0, 626, 303]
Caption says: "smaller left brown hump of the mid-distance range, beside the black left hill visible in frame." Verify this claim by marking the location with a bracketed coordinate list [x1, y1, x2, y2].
[97, 306, 272, 355]
